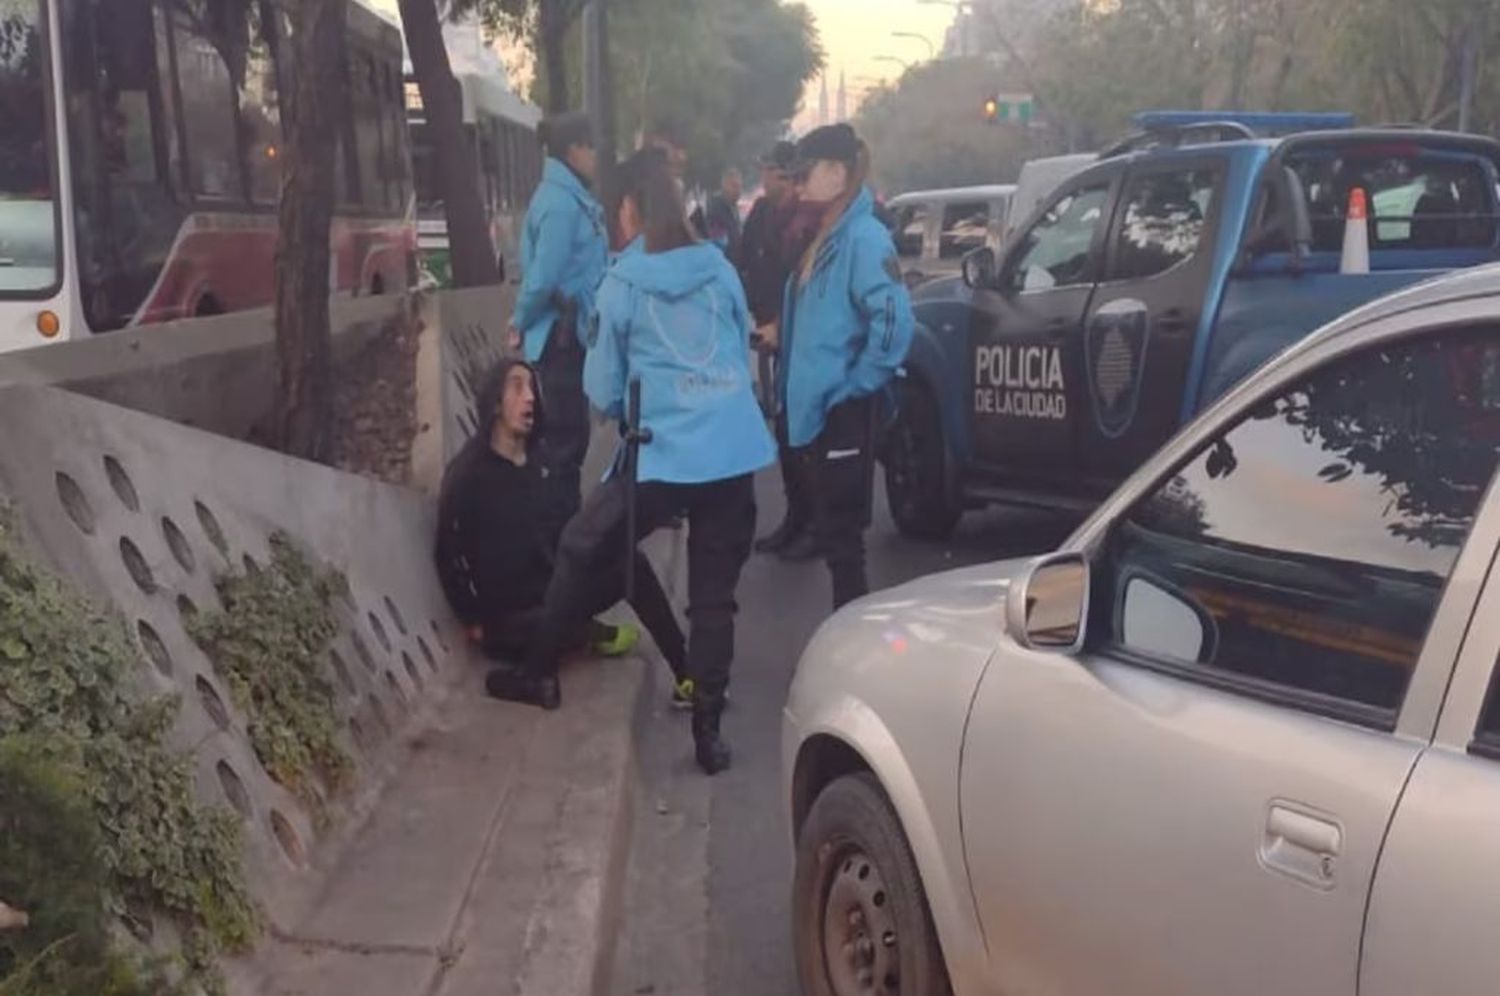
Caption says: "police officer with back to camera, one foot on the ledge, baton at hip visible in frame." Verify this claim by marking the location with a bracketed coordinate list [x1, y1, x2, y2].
[491, 150, 776, 774]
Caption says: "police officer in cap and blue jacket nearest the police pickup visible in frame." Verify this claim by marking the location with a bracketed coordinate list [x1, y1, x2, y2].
[780, 125, 914, 609]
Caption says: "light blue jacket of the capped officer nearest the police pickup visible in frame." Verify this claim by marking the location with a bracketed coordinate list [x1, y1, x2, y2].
[780, 188, 915, 447]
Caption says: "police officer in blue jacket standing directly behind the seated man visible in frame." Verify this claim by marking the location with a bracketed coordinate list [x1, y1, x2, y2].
[512, 114, 609, 528]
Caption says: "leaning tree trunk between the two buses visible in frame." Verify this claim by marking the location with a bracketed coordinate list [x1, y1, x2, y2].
[399, 0, 500, 287]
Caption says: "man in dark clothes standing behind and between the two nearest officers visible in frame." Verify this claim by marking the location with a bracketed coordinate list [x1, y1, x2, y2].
[737, 141, 822, 560]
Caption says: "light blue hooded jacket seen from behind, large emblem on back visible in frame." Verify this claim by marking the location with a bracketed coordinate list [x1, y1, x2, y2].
[584, 243, 776, 485]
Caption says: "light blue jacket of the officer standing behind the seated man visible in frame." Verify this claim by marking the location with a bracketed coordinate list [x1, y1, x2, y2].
[512, 159, 609, 363]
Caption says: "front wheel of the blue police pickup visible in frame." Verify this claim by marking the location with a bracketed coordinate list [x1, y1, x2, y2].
[885, 380, 963, 540]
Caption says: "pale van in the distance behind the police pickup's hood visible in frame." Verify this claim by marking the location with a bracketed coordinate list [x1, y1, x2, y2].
[885, 185, 1016, 285]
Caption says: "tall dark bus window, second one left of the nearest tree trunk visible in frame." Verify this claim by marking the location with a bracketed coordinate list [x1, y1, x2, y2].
[173, 3, 245, 201]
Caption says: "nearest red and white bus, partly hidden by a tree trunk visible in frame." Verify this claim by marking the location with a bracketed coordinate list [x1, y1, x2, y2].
[0, 0, 416, 351]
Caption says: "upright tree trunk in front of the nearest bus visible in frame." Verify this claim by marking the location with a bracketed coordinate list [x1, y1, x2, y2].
[275, 0, 348, 461]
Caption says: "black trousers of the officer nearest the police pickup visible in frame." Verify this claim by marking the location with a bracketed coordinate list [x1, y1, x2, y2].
[801, 398, 876, 611]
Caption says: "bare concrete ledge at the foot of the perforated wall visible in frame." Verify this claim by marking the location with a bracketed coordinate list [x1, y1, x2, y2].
[257, 659, 647, 996]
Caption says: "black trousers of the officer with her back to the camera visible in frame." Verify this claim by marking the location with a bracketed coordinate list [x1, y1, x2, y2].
[527, 474, 755, 704]
